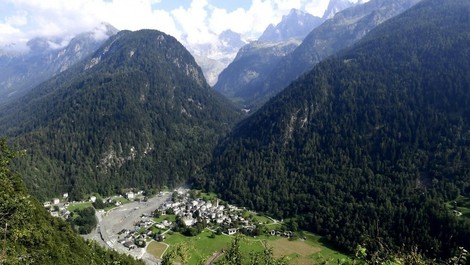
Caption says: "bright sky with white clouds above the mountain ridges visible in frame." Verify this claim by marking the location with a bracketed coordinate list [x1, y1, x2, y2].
[0, 0, 357, 50]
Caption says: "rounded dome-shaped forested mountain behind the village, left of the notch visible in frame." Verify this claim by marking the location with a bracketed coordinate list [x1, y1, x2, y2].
[0, 30, 240, 198]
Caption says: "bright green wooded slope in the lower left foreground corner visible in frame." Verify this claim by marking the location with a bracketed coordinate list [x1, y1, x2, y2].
[0, 139, 143, 265]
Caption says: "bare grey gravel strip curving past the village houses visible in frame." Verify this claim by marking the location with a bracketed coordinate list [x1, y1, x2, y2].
[85, 192, 171, 264]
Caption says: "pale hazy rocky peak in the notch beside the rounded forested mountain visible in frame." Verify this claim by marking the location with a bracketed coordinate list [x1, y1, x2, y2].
[182, 30, 246, 85]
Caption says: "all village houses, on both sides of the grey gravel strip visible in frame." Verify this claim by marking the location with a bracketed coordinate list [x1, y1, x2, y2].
[44, 189, 293, 253]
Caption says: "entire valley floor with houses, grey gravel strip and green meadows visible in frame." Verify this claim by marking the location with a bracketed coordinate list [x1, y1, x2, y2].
[39, 188, 346, 264]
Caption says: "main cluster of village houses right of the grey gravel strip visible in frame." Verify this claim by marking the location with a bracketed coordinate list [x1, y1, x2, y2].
[113, 189, 293, 249]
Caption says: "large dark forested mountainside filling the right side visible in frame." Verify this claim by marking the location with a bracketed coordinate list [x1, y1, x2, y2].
[195, 0, 470, 264]
